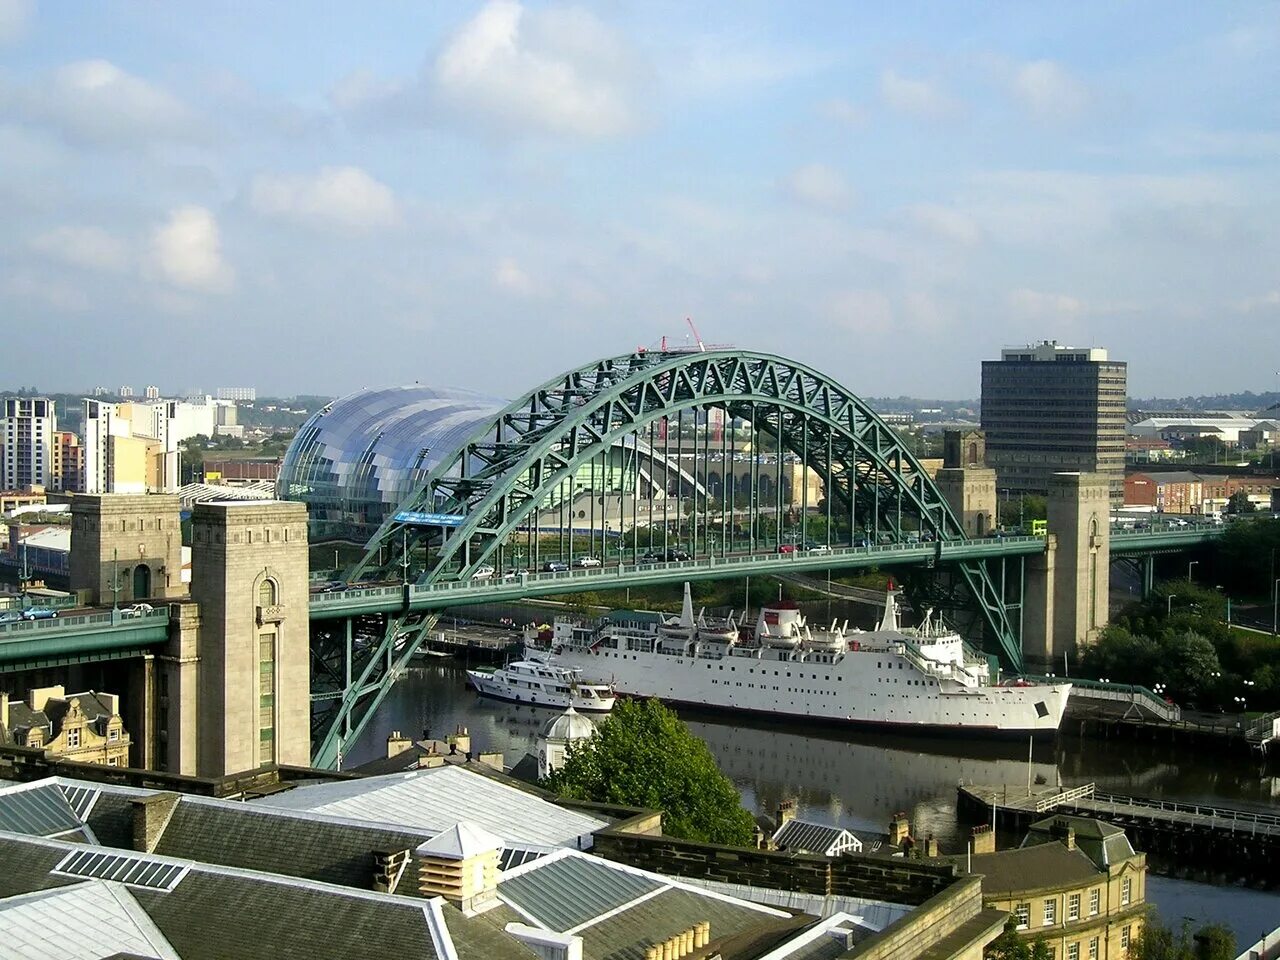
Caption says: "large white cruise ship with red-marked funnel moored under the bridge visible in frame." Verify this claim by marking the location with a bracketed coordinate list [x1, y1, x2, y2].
[526, 584, 1071, 737]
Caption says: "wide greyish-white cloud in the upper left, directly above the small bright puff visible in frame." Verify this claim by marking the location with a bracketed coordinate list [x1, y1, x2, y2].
[0, 58, 197, 145]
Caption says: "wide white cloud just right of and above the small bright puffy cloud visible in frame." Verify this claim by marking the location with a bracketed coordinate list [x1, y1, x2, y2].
[250, 166, 399, 229]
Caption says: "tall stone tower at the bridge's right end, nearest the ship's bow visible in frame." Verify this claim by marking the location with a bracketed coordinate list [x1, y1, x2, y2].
[1047, 474, 1111, 663]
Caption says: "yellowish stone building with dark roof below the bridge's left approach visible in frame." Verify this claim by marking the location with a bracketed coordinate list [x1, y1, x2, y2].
[0, 686, 131, 767]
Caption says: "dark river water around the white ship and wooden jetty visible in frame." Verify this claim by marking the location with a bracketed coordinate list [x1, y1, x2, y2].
[355, 660, 1280, 948]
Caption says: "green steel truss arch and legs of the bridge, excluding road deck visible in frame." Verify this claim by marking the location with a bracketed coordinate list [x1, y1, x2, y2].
[314, 351, 1021, 765]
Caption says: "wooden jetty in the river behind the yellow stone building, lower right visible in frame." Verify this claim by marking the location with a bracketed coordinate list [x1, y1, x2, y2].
[957, 783, 1280, 890]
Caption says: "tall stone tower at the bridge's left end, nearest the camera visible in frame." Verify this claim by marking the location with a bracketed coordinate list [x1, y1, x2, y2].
[191, 500, 311, 777]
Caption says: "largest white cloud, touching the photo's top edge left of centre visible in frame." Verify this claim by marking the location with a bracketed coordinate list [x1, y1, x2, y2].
[433, 0, 635, 138]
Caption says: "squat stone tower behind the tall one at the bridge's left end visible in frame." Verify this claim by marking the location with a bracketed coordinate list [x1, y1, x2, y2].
[70, 493, 187, 605]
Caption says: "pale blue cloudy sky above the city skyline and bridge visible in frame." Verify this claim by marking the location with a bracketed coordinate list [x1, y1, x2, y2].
[0, 0, 1280, 399]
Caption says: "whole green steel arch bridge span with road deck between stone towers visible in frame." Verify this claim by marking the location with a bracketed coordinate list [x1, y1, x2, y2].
[302, 351, 1228, 767]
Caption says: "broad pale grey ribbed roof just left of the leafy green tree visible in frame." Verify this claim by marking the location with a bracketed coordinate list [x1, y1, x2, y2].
[252, 764, 608, 847]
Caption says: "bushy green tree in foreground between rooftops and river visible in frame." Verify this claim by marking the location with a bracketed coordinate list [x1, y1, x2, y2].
[544, 700, 755, 846]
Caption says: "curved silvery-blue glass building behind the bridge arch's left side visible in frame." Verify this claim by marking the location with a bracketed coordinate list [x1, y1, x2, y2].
[275, 384, 507, 543]
